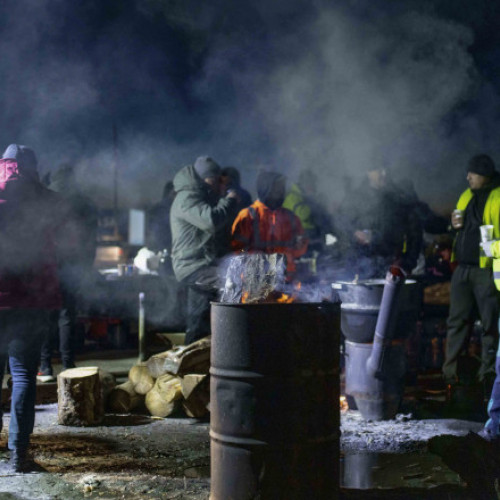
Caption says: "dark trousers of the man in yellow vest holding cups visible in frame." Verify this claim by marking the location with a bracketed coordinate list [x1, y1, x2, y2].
[443, 264, 499, 383]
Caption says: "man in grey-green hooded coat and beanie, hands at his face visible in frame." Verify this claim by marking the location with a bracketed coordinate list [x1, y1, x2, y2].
[170, 156, 238, 344]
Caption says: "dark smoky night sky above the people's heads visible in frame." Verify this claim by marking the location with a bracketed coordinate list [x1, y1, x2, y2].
[0, 0, 500, 208]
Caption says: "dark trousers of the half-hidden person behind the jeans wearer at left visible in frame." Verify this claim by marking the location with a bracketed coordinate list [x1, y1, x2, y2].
[40, 290, 76, 372]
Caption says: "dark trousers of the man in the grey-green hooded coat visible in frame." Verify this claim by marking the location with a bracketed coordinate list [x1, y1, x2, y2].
[181, 266, 218, 344]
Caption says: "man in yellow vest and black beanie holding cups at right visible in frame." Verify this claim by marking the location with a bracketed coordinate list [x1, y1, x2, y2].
[443, 154, 500, 397]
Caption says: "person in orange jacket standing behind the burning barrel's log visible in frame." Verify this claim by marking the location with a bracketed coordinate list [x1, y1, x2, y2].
[231, 171, 308, 280]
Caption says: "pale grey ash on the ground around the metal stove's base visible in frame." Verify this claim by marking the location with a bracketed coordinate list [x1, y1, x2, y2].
[340, 410, 483, 453]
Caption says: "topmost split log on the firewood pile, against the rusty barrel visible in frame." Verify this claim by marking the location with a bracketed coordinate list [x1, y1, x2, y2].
[147, 337, 210, 378]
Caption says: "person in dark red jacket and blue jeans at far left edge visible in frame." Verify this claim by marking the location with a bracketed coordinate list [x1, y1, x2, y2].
[0, 144, 61, 472]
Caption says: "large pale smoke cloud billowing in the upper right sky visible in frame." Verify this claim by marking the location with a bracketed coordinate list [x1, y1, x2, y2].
[197, 8, 482, 213]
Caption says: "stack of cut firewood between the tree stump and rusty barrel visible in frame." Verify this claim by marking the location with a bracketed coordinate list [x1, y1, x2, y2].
[108, 337, 210, 418]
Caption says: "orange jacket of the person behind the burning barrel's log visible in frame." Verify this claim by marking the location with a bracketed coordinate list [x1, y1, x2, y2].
[231, 200, 307, 273]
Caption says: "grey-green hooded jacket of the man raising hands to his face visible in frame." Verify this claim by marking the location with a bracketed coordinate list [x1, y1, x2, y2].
[170, 165, 236, 281]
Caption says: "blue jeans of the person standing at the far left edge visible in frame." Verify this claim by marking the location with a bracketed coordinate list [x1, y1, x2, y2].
[0, 309, 48, 450]
